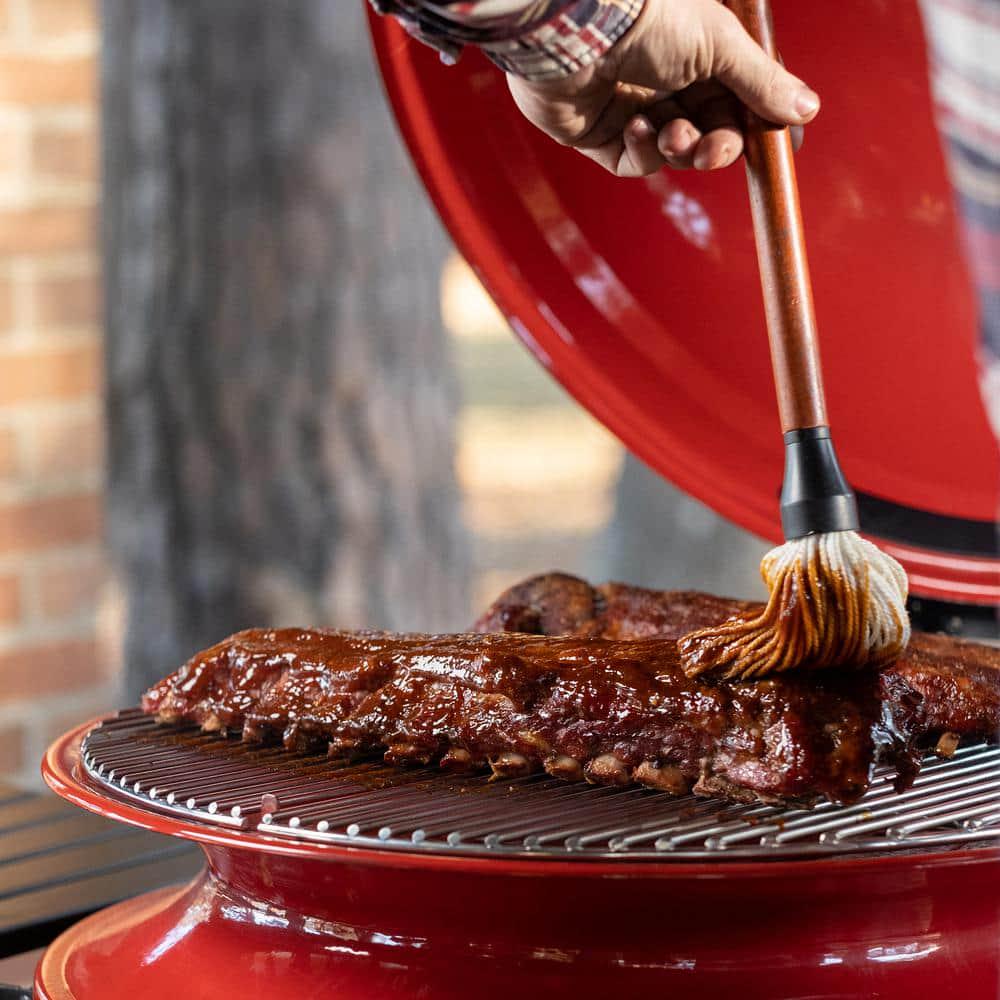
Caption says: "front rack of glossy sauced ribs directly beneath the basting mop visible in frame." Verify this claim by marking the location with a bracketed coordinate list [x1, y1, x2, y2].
[144, 630, 880, 801]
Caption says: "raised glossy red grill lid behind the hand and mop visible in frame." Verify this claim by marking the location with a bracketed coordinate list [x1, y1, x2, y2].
[372, 0, 1000, 604]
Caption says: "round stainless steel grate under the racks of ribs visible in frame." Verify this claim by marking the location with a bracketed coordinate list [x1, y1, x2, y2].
[83, 710, 1000, 861]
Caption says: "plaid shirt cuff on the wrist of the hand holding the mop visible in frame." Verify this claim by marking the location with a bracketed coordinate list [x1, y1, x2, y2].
[371, 0, 645, 80]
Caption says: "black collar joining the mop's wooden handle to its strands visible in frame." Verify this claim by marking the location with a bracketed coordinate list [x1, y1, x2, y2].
[781, 427, 858, 541]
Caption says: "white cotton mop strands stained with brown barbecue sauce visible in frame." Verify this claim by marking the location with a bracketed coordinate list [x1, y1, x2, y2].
[679, 531, 910, 680]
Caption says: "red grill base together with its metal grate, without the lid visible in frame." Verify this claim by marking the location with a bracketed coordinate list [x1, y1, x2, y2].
[35, 710, 1000, 1000]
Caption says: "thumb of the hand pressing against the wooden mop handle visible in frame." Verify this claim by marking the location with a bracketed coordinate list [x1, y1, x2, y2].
[710, 3, 819, 125]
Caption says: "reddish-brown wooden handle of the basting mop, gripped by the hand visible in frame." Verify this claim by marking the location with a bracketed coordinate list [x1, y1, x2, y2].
[726, 0, 827, 431]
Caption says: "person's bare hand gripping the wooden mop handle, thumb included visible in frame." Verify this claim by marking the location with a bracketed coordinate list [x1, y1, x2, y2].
[508, 0, 819, 177]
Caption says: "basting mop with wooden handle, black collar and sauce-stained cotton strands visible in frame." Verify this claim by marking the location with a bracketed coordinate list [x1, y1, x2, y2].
[679, 0, 910, 679]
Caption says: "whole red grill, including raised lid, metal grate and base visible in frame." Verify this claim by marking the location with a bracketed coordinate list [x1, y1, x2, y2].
[36, 0, 1000, 1000]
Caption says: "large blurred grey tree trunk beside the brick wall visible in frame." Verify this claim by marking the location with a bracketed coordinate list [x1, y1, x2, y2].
[102, 0, 470, 697]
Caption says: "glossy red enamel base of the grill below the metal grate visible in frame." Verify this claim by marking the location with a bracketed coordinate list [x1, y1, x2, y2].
[36, 726, 1000, 1000]
